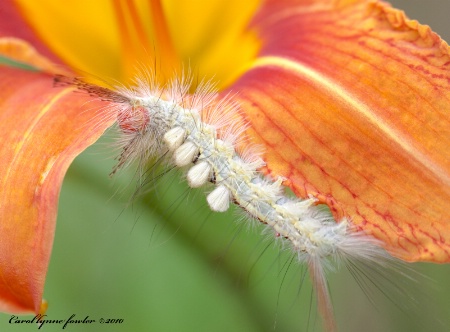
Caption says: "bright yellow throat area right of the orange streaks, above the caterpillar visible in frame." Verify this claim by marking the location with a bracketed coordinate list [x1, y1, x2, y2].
[162, 0, 263, 88]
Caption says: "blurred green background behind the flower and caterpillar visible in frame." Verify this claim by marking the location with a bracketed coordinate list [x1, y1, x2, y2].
[0, 0, 450, 332]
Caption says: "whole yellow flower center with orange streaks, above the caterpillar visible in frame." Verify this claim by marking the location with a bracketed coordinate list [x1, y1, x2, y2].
[17, 0, 260, 88]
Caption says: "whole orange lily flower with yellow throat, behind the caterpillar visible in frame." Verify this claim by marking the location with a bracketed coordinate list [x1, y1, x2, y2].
[0, 0, 450, 330]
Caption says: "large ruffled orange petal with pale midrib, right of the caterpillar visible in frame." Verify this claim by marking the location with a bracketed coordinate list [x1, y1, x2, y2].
[233, 0, 450, 262]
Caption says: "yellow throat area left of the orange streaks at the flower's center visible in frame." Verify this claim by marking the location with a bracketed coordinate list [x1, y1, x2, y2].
[14, 0, 121, 79]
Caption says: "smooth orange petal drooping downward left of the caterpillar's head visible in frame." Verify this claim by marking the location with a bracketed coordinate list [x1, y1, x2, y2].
[0, 66, 113, 313]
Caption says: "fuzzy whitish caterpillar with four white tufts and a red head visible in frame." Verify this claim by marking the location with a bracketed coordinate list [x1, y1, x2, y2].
[55, 71, 418, 331]
